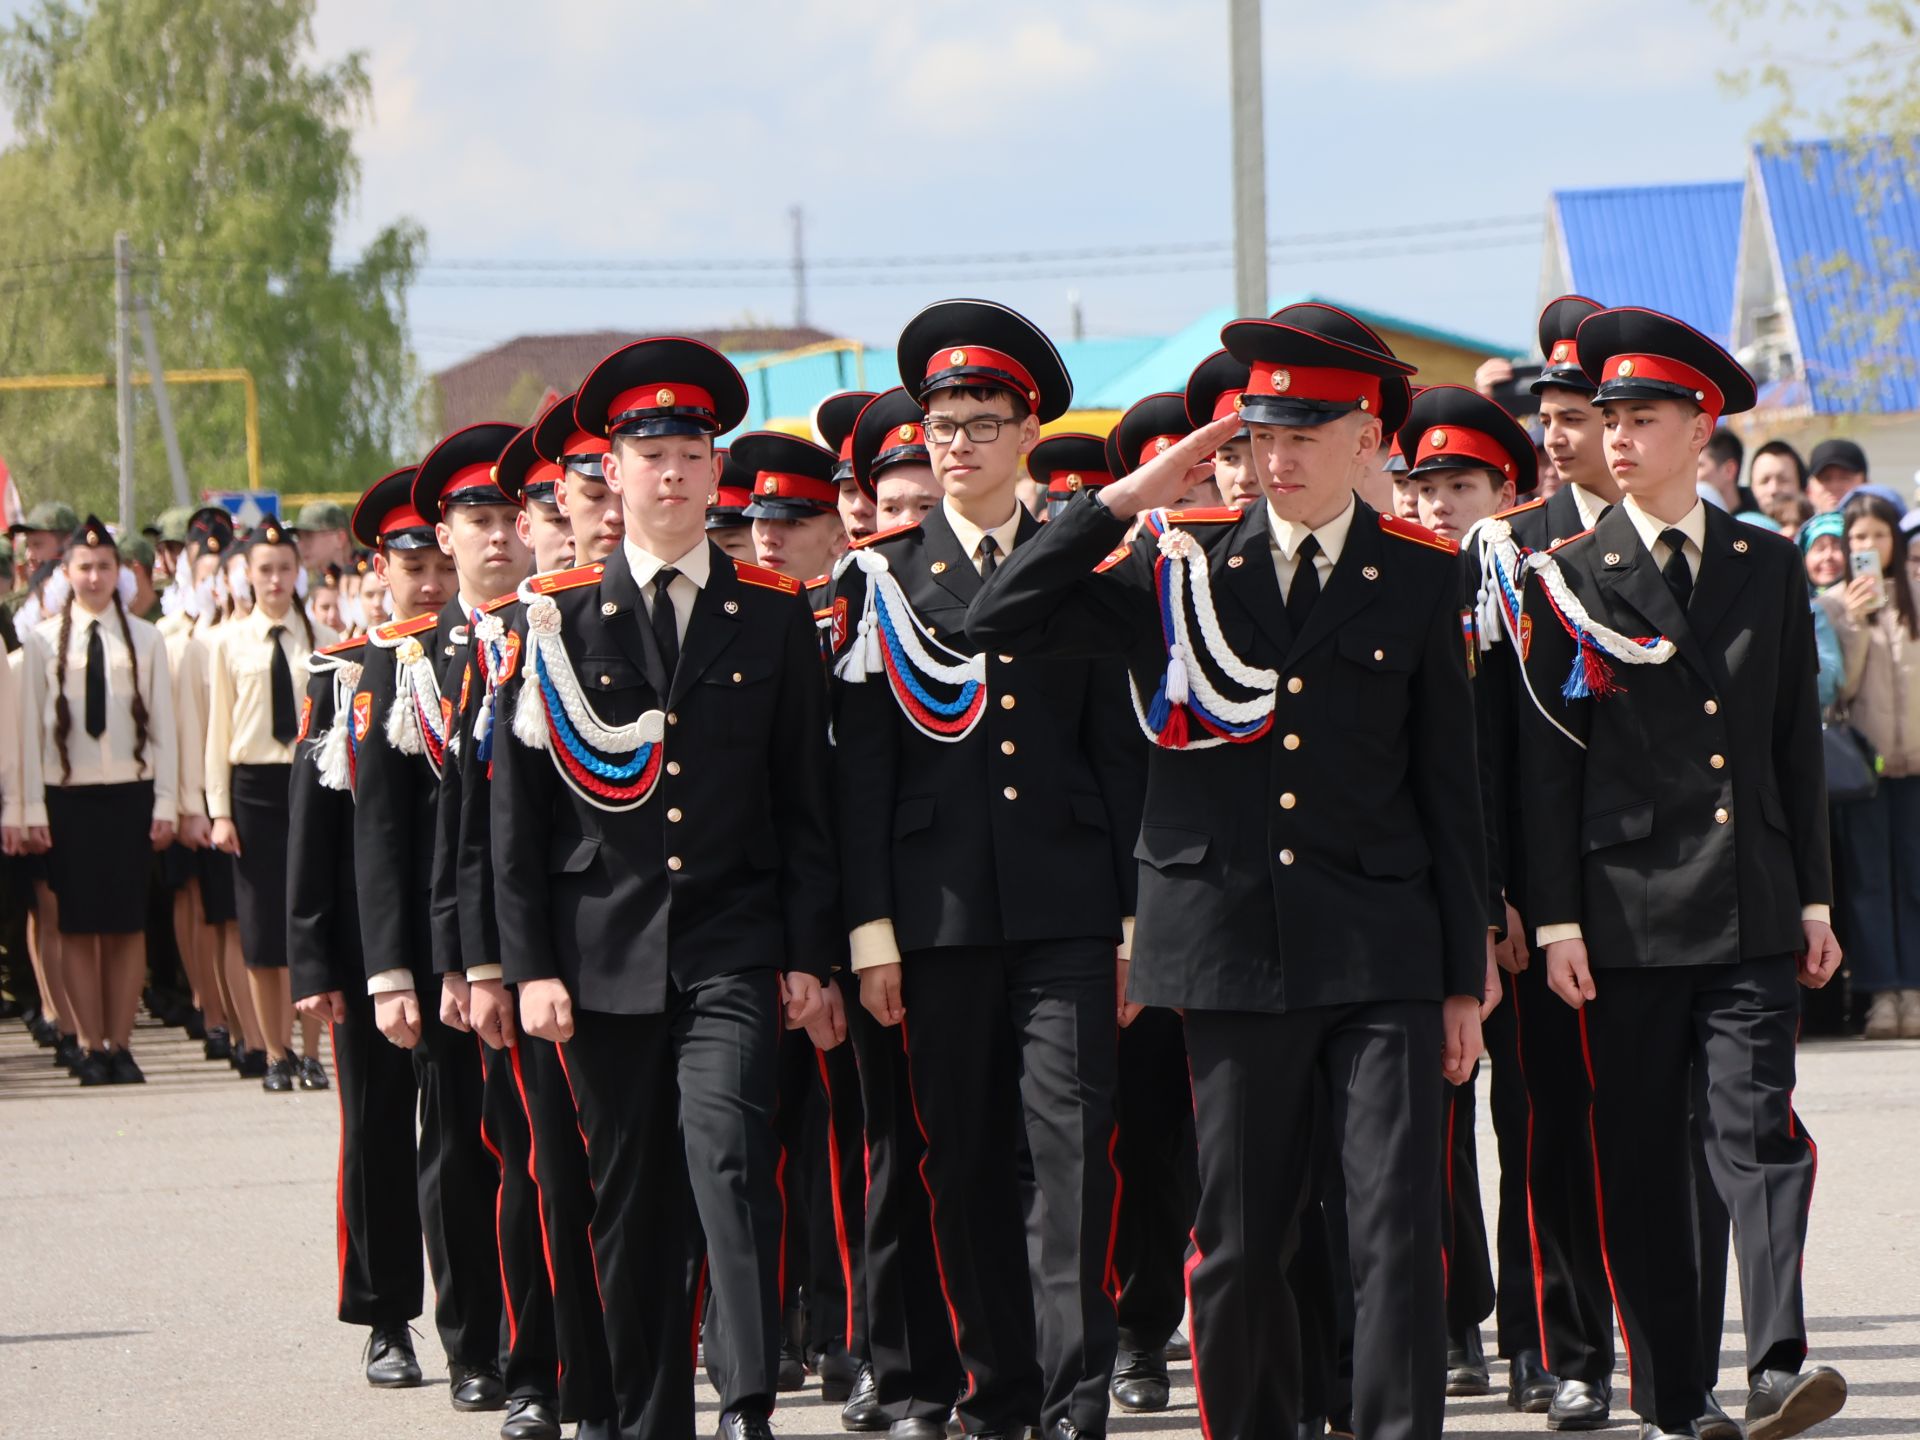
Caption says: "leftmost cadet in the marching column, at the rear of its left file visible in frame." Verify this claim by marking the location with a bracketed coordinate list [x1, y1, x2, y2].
[286, 467, 439, 1388]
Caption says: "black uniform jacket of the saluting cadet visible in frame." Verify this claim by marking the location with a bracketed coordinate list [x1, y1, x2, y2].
[968, 495, 1486, 1012]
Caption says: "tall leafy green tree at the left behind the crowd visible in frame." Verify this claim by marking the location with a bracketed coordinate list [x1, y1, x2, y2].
[0, 0, 424, 515]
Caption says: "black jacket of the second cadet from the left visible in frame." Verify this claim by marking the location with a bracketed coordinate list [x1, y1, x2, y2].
[351, 597, 467, 993]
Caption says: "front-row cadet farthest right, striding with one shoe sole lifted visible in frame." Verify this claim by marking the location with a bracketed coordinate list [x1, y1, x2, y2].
[1519, 307, 1847, 1440]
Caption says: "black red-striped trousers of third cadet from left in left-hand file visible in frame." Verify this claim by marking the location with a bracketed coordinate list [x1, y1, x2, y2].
[474, 1037, 561, 1405]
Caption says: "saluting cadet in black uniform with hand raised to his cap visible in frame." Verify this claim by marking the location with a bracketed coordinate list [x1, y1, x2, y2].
[968, 305, 1492, 1440]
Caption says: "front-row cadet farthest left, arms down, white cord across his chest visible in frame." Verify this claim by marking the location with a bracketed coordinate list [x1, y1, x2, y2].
[492, 338, 841, 1440]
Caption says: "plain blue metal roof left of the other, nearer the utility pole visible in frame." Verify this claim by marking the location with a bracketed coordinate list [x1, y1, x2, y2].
[1553, 180, 1747, 344]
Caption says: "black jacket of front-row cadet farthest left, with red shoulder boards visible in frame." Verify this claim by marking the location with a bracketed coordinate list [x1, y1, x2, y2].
[492, 543, 845, 1014]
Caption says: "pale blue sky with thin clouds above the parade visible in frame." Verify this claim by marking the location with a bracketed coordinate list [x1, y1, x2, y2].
[0, 0, 1858, 369]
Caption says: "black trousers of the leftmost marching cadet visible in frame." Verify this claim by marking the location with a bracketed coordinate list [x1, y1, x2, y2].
[330, 985, 426, 1325]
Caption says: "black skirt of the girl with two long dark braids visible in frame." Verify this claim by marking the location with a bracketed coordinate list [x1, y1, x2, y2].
[46, 780, 154, 935]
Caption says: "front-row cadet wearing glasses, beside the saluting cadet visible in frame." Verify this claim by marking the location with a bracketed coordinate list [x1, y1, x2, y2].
[831, 300, 1139, 1436]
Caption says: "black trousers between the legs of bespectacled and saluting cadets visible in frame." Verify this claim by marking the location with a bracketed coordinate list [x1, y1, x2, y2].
[1110, 1010, 1200, 1352]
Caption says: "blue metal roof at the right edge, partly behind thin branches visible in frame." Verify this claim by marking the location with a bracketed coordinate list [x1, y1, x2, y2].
[1749, 140, 1920, 415]
